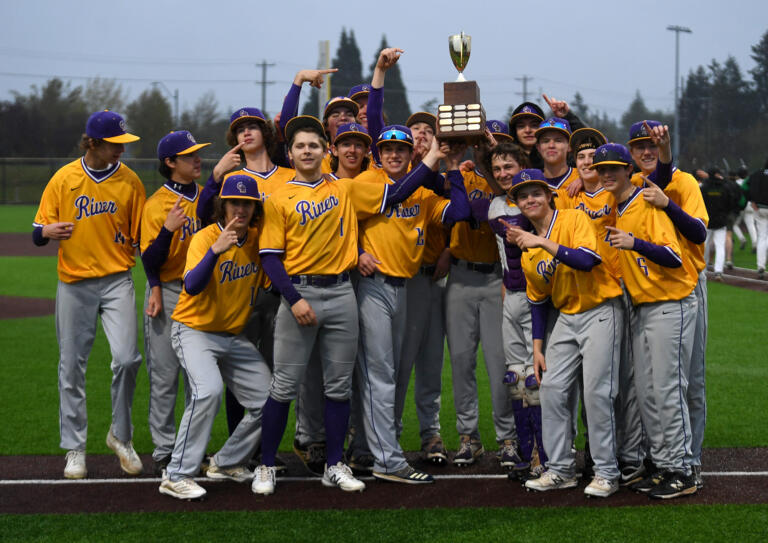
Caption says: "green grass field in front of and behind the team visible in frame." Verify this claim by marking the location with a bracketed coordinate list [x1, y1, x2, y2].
[0, 206, 768, 543]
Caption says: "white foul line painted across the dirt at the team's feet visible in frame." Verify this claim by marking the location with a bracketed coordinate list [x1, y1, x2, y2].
[0, 471, 768, 486]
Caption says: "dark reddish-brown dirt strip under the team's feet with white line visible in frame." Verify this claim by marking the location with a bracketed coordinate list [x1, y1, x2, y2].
[0, 448, 768, 514]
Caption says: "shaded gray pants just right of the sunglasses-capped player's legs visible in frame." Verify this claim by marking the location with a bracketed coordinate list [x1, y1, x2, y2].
[395, 272, 445, 443]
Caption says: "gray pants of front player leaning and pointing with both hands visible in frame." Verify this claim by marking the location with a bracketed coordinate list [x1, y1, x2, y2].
[539, 298, 623, 481]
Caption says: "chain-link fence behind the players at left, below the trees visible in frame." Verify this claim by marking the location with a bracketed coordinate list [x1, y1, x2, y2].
[0, 157, 216, 205]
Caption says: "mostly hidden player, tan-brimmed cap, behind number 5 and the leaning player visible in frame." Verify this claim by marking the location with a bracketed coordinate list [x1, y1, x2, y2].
[557, 128, 645, 486]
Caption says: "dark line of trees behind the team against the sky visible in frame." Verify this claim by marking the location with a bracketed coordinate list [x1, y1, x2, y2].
[0, 29, 768, 170]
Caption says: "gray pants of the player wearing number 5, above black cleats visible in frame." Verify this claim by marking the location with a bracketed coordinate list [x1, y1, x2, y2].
[632, 292, 697, 475]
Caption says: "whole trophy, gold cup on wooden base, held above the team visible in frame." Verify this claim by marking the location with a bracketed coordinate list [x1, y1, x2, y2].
[437, 32, 485, 143]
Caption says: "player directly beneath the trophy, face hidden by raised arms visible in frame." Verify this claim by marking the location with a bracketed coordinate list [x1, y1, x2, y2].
[445, 120, 520, 468]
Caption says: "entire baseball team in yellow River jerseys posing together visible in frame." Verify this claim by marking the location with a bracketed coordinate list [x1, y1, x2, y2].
[33, 48, 748, 499]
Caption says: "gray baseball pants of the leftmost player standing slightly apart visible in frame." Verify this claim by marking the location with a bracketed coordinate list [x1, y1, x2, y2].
[56, 271, 141, 451]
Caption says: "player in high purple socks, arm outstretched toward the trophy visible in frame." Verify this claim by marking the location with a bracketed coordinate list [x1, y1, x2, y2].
[251, 116, 444, 494]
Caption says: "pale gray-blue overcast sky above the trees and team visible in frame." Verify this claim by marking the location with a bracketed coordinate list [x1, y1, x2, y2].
[0, 0, 768, 126]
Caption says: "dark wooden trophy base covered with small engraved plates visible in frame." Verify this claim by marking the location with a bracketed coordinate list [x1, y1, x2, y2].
[437, 81, 485, 144]
